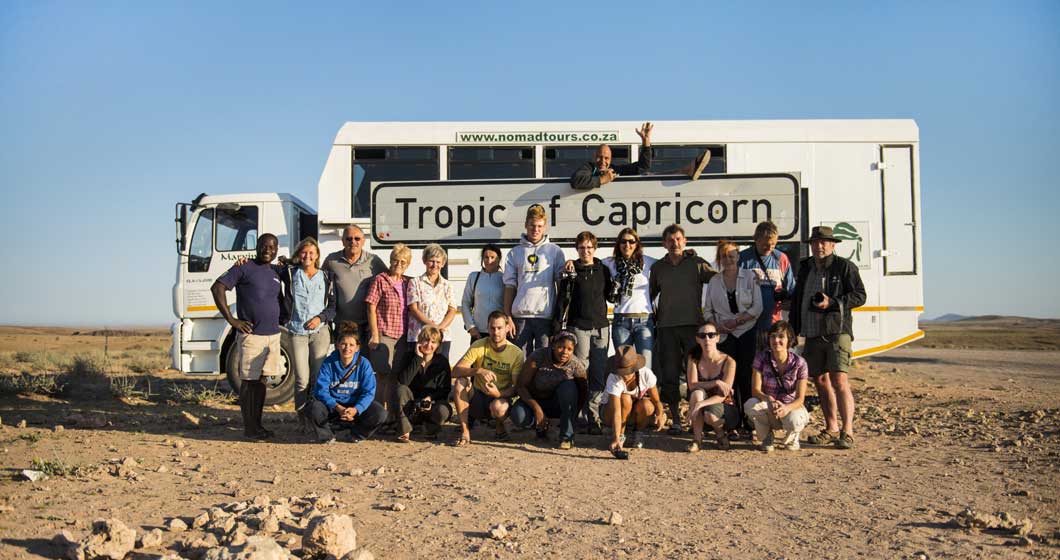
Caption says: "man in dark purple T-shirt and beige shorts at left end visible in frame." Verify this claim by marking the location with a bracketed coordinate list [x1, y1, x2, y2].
[210, 233, 287, 440]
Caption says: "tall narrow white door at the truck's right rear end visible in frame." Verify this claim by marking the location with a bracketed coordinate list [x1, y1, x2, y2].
[880, 145, 917, 276]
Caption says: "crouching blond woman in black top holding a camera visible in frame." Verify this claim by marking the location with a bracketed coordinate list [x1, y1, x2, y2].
[391, 326, 453, 442]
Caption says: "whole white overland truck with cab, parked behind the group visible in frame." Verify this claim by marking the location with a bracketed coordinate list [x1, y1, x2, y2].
[172, 120, 923, 404]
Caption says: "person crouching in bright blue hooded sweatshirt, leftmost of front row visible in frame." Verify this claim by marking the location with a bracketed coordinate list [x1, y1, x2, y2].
[310, 322, 387, 443]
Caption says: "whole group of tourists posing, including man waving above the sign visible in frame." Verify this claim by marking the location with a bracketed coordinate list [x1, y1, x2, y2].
[212, 123, 865, 457]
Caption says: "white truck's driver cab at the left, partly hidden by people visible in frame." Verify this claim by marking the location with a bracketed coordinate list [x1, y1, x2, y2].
[171, 193, 317, 404]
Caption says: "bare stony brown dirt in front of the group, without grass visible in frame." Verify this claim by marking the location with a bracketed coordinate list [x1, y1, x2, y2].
[0, 348, 1060, 558]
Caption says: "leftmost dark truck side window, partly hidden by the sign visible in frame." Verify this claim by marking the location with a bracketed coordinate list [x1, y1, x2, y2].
[352, 146, 441, 217]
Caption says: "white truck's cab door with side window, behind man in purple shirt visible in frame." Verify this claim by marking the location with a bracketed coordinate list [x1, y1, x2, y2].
[181, 205, 260, 317]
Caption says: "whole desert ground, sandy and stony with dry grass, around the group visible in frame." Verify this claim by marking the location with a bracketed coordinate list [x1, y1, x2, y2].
[0, 317, 1060, 559]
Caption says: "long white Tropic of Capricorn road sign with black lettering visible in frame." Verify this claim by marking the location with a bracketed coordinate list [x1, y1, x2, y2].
[372, 173, 799, 246]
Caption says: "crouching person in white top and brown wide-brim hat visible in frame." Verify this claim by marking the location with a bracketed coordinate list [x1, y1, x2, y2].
[603, 346, 666, 457]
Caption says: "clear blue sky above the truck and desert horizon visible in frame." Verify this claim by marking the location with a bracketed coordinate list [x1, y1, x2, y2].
[0, 0, 1060, 326]
